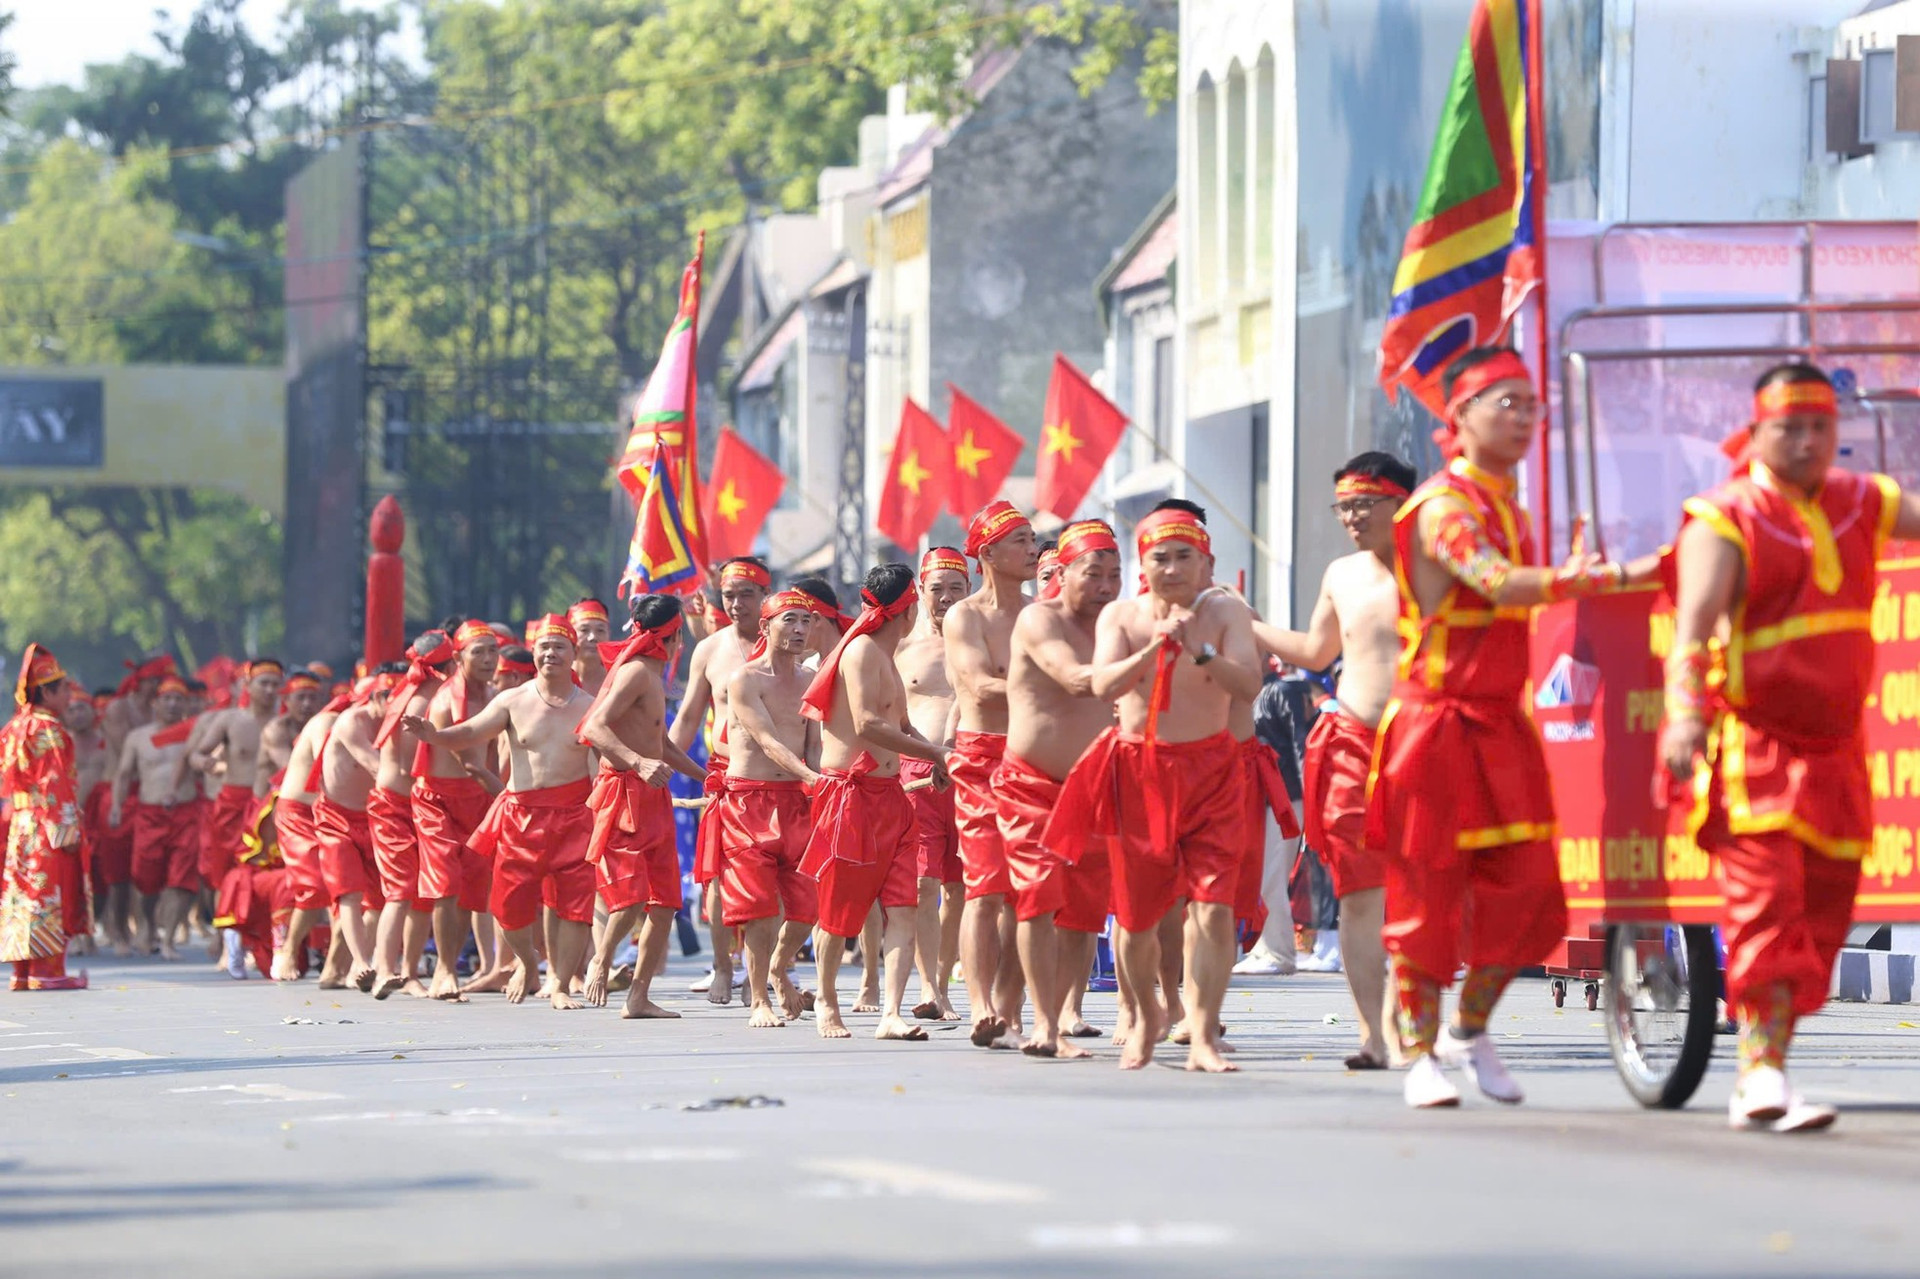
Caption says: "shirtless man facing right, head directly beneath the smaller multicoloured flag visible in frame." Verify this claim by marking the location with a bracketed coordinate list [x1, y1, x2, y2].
[580, 595, 707, 1018]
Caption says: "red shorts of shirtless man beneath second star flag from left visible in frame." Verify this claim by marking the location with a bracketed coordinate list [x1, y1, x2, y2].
[801, 755, 920, 937]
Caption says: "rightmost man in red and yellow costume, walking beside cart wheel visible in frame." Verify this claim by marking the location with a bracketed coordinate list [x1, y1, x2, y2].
[1661, 365, 1920, 1133]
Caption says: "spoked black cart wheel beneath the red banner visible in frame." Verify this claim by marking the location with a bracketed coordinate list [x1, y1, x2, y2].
[1607, 924, 1720, 1110]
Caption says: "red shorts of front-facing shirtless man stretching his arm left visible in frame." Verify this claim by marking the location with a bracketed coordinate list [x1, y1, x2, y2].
[488, 778, 593, 931]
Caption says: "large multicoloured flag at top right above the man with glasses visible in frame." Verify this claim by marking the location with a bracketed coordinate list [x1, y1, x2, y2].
[1380, 0, 1546, 415]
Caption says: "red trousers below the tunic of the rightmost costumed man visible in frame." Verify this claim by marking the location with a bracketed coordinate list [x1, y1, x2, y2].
[1713, 832, 1860, 1016]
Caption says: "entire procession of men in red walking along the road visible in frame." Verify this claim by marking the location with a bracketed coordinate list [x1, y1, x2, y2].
[0, 348, 1889, 1131]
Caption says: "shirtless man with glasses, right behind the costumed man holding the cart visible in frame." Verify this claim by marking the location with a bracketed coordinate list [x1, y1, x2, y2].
[1254, 453, 1415, 1070]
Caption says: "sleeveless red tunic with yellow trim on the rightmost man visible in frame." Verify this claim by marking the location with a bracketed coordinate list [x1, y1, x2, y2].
[1686, 463, 1901, 862]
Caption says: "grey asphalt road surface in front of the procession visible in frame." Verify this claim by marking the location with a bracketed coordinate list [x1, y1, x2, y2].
[0, 944, 1920, 1279]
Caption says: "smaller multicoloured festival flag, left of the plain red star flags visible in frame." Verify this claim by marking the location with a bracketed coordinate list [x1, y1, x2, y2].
[614, 230, 707, 597]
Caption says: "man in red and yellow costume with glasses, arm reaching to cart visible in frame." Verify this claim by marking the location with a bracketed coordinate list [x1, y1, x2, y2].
[1365, 348, 1659, 1108]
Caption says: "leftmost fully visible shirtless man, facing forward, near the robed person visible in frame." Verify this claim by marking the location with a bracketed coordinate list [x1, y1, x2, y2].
[108, 676, 200, 960]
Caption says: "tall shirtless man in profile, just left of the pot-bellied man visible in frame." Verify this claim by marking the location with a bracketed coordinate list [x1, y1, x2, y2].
[941, 501, 1041, 1049]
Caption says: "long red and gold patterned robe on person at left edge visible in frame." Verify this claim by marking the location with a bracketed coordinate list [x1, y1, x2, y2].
[0, 707, 86, 962]
